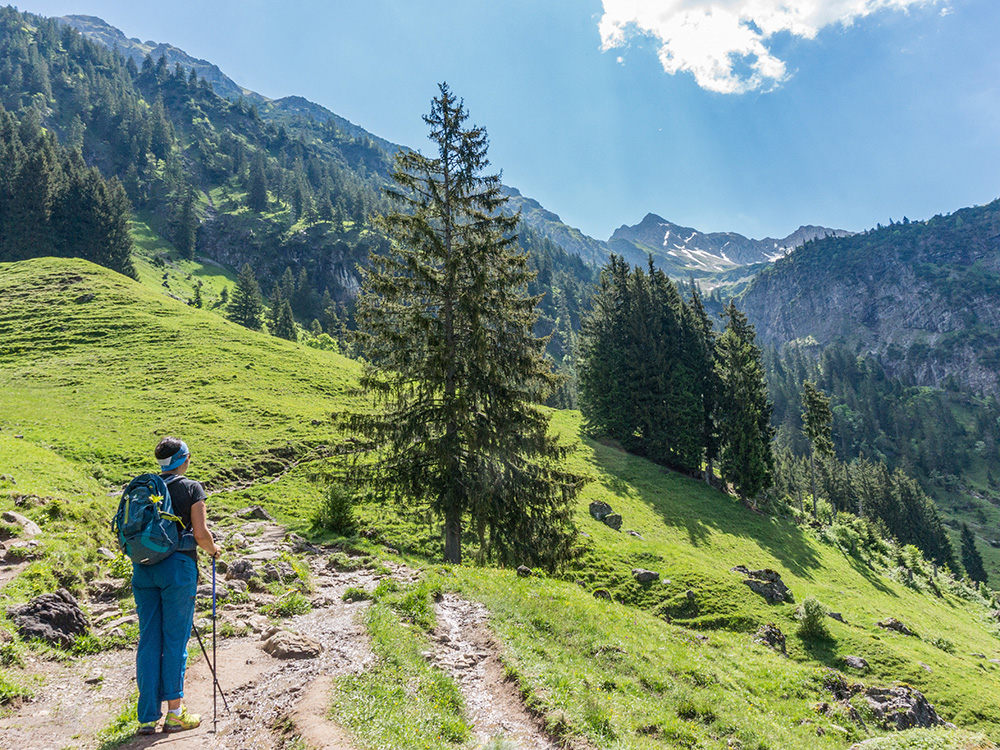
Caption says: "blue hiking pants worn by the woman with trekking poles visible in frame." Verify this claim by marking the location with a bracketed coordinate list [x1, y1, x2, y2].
[132, 552, 198, 723]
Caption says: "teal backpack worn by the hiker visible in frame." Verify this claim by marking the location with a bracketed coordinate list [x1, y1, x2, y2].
[111, 474, 195, 565]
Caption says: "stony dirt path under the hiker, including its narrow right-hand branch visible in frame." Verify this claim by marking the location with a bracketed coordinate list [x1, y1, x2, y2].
[0, 521, 555, 750]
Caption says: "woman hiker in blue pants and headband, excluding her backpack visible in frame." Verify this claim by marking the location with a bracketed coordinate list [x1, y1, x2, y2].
[132, 437, 222, 734]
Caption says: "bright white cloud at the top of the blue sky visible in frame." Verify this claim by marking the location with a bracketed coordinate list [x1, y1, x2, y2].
[600, 0, 947, 94]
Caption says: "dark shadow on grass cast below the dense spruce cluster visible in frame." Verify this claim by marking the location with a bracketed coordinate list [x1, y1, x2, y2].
[586, 440, 820, 580]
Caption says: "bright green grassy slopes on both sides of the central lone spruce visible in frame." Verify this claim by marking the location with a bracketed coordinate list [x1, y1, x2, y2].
[0, 259, 1000, 748]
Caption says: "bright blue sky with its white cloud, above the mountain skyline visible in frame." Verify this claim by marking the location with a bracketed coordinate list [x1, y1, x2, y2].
[18, 0, 1000, 239]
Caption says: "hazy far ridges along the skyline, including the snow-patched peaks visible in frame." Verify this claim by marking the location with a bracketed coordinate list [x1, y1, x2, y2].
[59, 15, 849, 278]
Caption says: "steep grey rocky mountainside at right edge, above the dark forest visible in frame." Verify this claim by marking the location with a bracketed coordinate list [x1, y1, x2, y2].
[741, 201, 1000, 394]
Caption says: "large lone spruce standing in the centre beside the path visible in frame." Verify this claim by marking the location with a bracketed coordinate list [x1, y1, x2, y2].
[345, 84, 580, 567]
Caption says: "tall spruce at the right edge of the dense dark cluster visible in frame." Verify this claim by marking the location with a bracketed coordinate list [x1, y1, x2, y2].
[715, 301, 774, 505]
